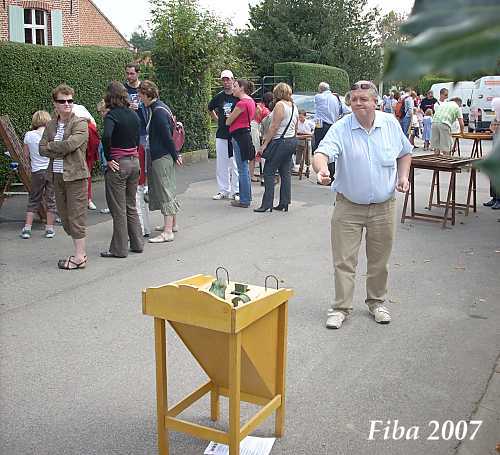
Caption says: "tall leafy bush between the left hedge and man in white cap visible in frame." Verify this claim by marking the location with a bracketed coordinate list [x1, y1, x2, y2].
[151, 0, 224, 150]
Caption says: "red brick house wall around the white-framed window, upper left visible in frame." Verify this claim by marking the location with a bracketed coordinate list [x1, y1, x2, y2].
[0, 0, 128, 47]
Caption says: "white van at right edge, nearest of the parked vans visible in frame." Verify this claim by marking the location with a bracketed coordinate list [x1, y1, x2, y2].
[470, 76, 500, 131]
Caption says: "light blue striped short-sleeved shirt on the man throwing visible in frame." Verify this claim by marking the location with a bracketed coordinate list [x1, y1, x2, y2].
[315, 111, 413, 204]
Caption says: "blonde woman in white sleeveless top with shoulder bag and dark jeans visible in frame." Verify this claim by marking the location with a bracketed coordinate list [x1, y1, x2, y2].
[254, 82, 299, 212]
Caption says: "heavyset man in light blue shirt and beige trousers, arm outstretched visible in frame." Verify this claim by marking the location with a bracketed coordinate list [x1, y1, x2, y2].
[313, 81, 413, 329]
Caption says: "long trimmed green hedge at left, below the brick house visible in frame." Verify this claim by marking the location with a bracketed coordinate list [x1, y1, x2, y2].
[0, 42, 133, 137]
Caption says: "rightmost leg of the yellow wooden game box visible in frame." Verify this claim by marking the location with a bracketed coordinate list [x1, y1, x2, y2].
[274, 302, 288, 438]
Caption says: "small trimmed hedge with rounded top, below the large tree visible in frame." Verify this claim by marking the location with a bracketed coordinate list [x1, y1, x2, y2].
[274, 62, 349, 94]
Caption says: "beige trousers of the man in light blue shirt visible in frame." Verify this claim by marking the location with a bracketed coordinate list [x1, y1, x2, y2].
[331, 193, 396, 314]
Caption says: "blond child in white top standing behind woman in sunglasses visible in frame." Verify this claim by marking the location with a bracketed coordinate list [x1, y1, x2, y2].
[21, 111, 56, 239]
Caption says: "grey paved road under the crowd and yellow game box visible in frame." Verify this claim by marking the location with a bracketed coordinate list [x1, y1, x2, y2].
[0, 147, 500, 455]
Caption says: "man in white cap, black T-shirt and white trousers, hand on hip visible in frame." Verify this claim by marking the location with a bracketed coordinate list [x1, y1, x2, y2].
[208, 70, 239, 200]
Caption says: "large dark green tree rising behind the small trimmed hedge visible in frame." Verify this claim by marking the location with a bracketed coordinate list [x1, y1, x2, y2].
[239, 0, 381, 80]
